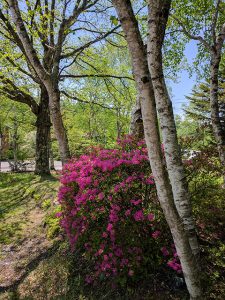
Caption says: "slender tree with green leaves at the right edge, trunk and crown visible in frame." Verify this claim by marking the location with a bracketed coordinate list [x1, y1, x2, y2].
[172, 0, 225, 180]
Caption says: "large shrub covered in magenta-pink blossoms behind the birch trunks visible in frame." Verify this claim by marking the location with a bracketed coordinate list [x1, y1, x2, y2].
[59, 137, 181, 283]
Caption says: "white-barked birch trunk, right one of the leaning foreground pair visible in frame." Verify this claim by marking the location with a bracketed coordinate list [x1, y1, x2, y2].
[147, 0, 199, 255]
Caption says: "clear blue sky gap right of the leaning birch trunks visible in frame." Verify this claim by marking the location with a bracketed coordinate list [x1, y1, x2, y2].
[169, 41, 197, 115]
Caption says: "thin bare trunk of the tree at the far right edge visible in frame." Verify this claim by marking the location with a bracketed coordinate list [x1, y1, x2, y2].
[210, 53, 225, 182]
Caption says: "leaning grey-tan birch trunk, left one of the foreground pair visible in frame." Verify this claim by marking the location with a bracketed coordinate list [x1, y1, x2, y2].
[113, 0, 201, 299]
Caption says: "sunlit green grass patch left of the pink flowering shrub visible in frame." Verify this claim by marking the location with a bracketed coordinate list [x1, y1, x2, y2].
[0, 173, 59, 244]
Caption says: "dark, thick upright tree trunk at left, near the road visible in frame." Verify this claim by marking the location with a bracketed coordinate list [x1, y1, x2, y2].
[35, 86, 51, 175]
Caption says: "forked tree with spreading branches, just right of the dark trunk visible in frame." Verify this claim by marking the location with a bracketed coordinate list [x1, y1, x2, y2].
[0, 0, 118, 162]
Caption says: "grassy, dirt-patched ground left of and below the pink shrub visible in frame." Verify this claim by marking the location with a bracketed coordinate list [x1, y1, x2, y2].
[0, 173, 186, 300]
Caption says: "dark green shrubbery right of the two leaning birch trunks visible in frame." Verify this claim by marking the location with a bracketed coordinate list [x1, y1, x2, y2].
[184, 147, 225, 299]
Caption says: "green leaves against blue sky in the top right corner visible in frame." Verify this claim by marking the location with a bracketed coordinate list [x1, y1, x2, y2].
[171, 0, 225, 79]
